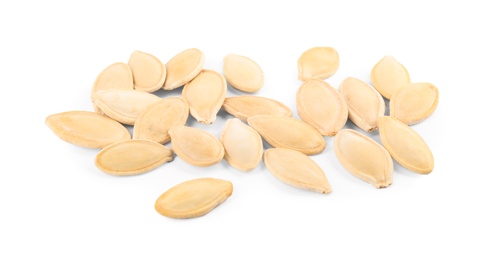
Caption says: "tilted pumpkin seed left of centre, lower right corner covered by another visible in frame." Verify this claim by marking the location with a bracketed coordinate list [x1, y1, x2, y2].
[133, 97, 189, 144]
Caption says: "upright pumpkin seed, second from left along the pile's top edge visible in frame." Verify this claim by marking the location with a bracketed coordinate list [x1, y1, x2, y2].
[128, 51, 166, 92]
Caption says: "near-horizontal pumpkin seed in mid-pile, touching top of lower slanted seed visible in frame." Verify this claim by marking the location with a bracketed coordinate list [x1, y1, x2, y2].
[248, 115, 326, 155]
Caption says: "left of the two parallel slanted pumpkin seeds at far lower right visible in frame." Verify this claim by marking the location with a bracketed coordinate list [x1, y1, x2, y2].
[334, 129, 393, 188]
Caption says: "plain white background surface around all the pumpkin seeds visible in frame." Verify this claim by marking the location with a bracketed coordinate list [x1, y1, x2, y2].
[0, 0, 486, 259]
